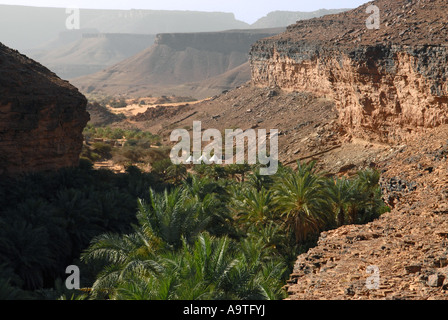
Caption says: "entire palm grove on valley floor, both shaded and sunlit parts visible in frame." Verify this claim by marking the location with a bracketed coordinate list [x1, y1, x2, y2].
[0, 158, 388, 300]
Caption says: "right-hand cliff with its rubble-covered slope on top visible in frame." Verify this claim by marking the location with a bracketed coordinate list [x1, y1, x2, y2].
[250, 0, 448, 143]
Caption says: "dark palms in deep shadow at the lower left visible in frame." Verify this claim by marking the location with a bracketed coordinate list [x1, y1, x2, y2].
[0, 162, 166, 299]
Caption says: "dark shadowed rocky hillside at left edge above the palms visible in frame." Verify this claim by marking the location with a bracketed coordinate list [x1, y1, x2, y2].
[0, 43, 89, 175]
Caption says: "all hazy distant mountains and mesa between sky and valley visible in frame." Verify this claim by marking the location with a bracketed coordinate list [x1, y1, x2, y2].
[0, 5, 354, 97]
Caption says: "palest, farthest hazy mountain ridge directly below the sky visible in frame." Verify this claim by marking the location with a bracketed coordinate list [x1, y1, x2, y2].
[0, 5, 350, 51]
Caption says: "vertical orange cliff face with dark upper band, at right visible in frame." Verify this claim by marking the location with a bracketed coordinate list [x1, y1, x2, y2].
[252, 40, 448, 142]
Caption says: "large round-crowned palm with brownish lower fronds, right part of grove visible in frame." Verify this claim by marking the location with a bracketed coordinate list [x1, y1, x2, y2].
[275, 162, 331, 243]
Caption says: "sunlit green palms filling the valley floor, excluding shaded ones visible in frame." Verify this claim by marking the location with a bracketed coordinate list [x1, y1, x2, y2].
[74, 163, 387, 300]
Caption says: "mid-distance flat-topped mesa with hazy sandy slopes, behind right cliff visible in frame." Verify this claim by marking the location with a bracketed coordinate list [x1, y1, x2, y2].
[72, 28, 284, 98]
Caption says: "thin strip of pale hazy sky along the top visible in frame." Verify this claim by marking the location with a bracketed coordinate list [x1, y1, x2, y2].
[0, 0, 370, 23]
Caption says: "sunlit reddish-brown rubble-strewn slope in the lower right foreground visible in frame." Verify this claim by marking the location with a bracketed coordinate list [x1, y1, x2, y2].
[287, 125, 448, 300]
